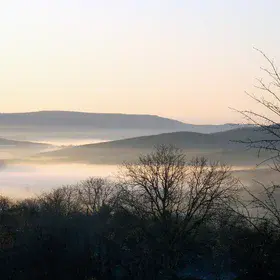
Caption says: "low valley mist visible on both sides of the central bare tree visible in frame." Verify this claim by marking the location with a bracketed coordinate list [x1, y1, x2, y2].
[0, 159, 280, 199]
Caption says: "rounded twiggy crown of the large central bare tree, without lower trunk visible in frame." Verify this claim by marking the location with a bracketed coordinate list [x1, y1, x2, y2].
[122, 145, 237, 226]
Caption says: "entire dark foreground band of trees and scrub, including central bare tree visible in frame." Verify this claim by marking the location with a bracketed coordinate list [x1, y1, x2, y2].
[0, 146, 280, 280]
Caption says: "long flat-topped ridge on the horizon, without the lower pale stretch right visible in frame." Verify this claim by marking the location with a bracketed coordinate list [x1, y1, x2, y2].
[0, 111, 189, 129]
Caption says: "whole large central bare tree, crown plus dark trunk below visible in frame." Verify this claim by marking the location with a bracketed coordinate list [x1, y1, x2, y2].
[118, 145, 238, 270]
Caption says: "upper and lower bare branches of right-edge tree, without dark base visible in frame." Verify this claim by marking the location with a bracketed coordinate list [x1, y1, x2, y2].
[232, 49, 280, 229]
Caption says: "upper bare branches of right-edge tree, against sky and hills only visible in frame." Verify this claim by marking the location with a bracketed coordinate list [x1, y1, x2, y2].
[235, 49, 280, 162]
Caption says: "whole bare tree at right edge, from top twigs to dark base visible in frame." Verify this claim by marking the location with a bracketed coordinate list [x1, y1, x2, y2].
[233, 50, 280, 279]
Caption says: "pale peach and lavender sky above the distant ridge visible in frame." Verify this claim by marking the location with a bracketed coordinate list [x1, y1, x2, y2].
[0, 0, 280, 123]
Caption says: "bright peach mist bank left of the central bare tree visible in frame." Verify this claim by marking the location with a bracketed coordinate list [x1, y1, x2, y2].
[0, 163, 117, 199]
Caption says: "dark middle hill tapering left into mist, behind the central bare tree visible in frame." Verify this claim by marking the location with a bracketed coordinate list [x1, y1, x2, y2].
[33, 128, 274, 165]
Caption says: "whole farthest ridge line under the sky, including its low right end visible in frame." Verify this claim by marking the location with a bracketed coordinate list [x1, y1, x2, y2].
[0, 111, 246, 133]
